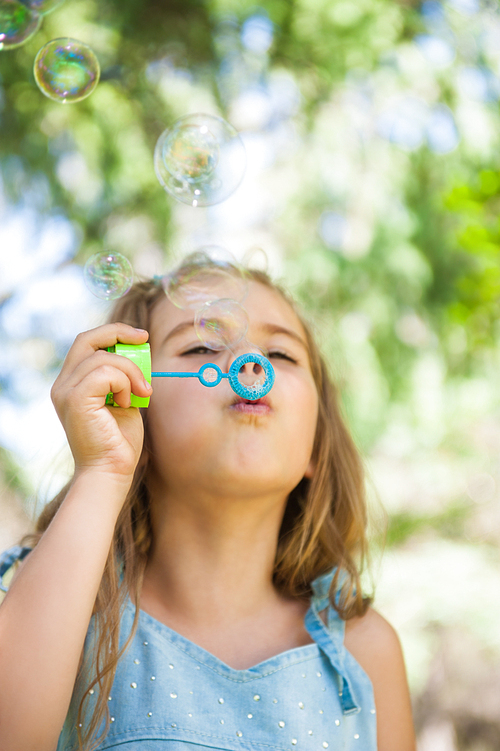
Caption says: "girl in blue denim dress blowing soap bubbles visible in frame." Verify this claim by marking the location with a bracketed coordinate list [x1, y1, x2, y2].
[0, 259, 415, 751]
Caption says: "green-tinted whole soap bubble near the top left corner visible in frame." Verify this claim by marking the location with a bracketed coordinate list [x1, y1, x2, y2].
[34, 38, 100, 104]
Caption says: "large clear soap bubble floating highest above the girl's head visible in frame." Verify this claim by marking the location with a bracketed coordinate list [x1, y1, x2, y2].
[154, 114, 246, 207]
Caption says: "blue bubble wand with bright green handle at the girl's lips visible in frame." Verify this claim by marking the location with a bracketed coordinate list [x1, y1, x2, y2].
[106, 342, 275, 407]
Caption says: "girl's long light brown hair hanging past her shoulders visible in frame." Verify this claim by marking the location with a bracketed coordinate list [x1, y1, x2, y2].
[30, 257, 370, 751]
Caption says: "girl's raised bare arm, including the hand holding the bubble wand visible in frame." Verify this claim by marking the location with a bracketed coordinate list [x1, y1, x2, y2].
[0, 324, 149, 751]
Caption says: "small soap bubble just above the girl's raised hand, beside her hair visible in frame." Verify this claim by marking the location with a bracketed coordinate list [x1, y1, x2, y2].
[83, 251, 134, 300]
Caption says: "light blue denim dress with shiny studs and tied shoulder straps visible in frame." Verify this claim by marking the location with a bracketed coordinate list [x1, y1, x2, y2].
[0, 547, 377, 751]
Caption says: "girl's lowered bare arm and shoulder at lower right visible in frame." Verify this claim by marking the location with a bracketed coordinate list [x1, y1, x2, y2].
[345, 608, 416, 751]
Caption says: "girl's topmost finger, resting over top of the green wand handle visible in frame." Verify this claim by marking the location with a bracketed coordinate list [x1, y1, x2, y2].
[59, 323, 149, 380]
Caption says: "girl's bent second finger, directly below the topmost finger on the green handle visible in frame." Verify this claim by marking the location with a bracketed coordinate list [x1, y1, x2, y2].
[52, 350, 152, 409]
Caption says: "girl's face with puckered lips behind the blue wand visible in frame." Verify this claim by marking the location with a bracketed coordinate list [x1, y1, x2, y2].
[147, 282, 318, 497]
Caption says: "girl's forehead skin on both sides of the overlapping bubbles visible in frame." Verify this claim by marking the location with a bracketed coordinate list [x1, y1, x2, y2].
[150, 281, 305, 339]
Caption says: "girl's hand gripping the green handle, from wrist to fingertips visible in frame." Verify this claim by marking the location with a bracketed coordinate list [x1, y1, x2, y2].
[51, 323, 151, 480]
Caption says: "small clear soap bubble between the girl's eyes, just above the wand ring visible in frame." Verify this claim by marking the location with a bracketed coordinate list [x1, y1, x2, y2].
[194, 298, 248, 351]
